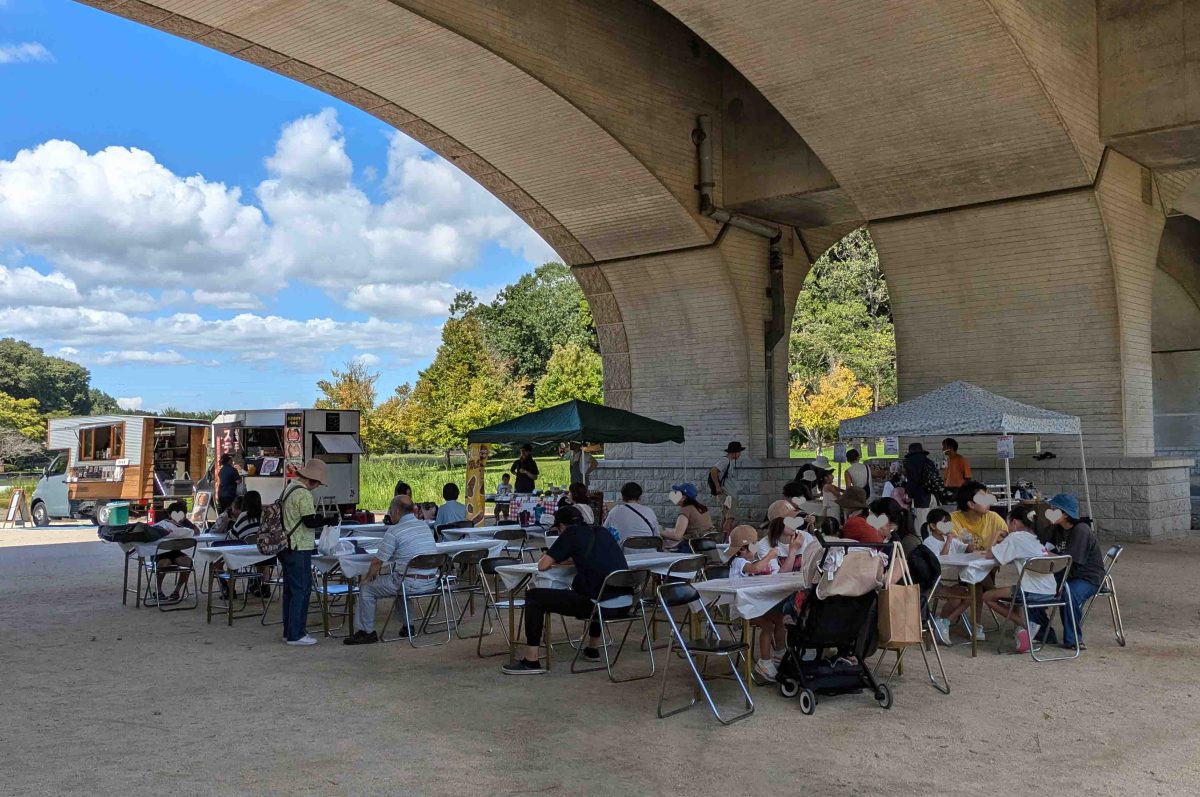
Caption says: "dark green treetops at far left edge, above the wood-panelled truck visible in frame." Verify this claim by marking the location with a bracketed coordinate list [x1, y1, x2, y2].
[0, 337, 91, 415]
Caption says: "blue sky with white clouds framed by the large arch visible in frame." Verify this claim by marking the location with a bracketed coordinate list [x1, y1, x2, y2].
[0, 0, 553, 409]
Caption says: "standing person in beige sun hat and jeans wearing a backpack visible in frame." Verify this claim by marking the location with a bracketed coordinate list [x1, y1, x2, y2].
[277, 460, 329, 646]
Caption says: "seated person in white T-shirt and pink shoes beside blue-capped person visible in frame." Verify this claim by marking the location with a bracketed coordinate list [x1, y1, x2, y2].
[983, 507, 1058, 653]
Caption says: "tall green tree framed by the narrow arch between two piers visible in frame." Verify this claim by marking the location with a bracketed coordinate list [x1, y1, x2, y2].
[788, 227, 896, 408]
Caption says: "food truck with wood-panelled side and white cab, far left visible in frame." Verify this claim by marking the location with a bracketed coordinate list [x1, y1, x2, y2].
[30, 415, 209, 526]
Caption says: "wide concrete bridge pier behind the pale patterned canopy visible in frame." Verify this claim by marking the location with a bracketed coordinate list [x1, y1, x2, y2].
[871, 151, 1190, 539]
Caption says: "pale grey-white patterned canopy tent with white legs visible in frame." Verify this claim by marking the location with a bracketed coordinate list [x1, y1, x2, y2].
[838, 382, 1092, 515]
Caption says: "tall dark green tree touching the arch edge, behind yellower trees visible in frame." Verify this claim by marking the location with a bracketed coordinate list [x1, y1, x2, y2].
[472, 263, 599, 384]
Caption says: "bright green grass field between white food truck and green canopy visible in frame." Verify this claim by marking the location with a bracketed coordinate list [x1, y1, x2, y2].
[359, 454, 570, 511]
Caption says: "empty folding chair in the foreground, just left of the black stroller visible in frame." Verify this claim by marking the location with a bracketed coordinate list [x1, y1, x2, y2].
[658, 583, 754, 725]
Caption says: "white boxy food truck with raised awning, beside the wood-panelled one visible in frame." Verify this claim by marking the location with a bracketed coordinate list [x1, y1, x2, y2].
[209, 409, 362, 514]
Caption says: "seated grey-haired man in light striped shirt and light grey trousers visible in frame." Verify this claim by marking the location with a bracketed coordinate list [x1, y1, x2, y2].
[343, 496, 438, 645]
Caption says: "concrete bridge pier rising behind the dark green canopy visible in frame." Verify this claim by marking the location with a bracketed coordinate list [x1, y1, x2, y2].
[574, 224, 809, 523]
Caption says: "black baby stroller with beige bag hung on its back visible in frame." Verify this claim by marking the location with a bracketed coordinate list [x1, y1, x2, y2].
[776, 534, 892, 714]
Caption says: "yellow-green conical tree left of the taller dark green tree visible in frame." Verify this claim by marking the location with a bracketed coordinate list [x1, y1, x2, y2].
[403, 313, 528, 450]
